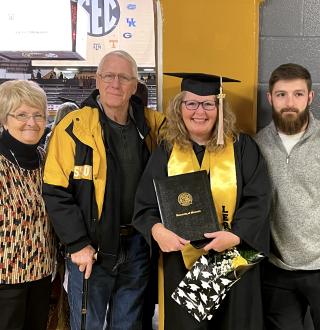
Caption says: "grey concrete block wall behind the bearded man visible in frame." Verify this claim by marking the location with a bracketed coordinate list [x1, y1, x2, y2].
[257, 0, 320, 130]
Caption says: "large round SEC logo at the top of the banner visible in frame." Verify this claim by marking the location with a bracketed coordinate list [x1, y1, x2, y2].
[78, 0, 120, 37]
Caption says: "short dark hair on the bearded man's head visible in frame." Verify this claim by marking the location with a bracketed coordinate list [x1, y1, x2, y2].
[269, 63, 312, 93]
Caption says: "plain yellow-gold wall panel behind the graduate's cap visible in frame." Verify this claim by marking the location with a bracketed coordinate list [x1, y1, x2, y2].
[160, 0, 261, 134]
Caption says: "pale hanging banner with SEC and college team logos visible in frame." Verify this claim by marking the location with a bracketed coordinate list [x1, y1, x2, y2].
[32, 0, 155, 67]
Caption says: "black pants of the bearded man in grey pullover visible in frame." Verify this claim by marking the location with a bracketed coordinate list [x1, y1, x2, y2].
[263, 262, 320, 330]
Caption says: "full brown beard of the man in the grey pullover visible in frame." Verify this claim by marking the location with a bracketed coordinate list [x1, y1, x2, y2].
[272, 105, 310, 135]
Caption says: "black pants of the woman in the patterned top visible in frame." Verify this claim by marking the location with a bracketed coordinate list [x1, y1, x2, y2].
[0, 276, 51, 330]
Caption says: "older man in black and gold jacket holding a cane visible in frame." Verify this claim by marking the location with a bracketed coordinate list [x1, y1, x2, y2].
[43, 51, 164, 330]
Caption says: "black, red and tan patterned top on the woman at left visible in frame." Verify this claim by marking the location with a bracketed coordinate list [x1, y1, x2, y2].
[0, 155, 54, 284]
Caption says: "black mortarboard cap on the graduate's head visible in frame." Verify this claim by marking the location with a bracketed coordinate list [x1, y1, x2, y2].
[164, 72, 240, 96]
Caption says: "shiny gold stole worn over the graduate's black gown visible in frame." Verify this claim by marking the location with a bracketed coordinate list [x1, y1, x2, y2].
[159, 138, 237, 329]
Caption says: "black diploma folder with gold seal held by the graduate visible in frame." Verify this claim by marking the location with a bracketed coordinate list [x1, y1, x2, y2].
[153, 171, 220, 241]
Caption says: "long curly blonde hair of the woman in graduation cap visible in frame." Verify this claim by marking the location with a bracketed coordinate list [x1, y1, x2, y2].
[159, 92, 238, 151]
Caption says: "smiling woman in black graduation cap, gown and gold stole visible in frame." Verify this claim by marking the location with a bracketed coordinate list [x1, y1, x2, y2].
[133, 74, 270, 330]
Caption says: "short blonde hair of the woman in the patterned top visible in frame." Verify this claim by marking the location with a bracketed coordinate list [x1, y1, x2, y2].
[0, 80, 47, 125]
